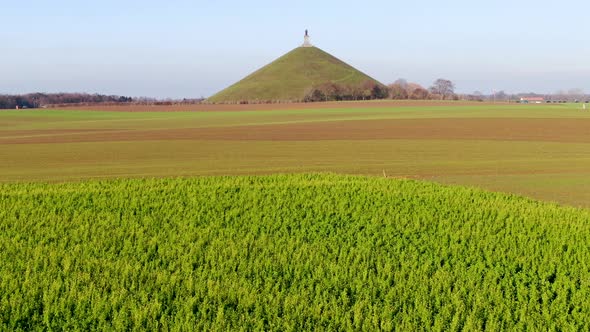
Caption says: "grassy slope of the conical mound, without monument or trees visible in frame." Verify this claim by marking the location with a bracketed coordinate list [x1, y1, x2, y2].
[207, 47, 384, 103]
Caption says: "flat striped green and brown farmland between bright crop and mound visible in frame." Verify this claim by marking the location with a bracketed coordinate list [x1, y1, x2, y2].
[0, 101, 590, 207]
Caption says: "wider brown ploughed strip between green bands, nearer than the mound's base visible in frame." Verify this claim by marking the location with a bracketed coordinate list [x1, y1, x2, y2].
[0, 118, 590, 144]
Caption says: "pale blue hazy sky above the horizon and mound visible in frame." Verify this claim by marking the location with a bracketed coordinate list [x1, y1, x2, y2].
[0, 0, 590, 98]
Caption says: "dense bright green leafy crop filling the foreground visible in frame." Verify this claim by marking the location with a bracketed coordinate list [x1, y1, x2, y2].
[0, 175, 590, 331]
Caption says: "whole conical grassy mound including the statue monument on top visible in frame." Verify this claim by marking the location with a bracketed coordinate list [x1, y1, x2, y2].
[207, 31, 385, 103]
